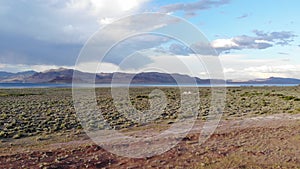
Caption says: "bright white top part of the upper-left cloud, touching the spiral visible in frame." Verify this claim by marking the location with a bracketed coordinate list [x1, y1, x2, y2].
[61, 0, 149, 40]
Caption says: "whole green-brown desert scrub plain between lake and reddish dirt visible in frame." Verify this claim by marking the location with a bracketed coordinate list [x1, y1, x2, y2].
[0, 86, 300, 139]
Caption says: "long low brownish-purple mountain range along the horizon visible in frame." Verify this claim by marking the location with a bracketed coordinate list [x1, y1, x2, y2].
[0, 68, 300, 84]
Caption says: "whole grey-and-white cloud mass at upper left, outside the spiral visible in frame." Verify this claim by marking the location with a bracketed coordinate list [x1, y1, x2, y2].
[0, 0, 148, 66]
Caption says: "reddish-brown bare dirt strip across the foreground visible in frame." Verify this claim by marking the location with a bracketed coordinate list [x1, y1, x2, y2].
[0, 114, 300, 169]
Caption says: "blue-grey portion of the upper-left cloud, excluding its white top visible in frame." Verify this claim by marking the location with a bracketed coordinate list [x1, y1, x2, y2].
[0, 0, 98, 66]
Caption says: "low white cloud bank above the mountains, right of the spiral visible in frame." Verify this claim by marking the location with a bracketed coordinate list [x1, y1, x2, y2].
[220, 54, 300, 80]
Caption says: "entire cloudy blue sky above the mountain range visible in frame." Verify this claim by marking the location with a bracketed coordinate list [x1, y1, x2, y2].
[0, 0, 300, 80]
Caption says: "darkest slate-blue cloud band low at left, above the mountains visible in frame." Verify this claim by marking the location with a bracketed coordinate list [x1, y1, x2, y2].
[0, 33, 82, 66]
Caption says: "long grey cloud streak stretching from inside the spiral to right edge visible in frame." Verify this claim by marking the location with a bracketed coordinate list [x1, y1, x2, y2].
[170, 30, 296, 55]
